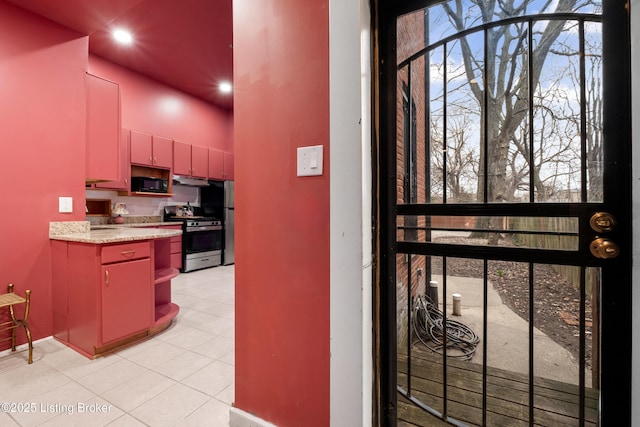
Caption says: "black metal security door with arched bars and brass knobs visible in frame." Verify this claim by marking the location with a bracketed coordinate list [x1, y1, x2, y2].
[377, 0, 631, 426]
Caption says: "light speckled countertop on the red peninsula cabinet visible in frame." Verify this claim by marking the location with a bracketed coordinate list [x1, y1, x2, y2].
[49, 221, 182, 244]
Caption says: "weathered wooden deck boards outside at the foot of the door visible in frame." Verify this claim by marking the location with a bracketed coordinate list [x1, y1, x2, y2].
[398, 347, 598, 426]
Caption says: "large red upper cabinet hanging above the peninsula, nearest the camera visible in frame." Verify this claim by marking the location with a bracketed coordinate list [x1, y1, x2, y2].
[86, 74, 121, 182]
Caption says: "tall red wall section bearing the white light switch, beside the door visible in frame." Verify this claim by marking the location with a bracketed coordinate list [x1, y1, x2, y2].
[233, 0, 330, 426]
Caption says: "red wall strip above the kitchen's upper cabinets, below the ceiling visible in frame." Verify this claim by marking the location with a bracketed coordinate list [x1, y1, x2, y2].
[89, 55, 233, 152]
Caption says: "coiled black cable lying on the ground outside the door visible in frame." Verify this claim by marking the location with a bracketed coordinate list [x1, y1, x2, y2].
[412, 295, 480, 360]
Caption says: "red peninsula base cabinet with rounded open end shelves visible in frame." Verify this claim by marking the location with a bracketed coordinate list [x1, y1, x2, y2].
[51, 238, 179, 358]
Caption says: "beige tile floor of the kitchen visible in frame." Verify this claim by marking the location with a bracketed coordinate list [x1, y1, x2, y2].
[0, 266, 234, 427]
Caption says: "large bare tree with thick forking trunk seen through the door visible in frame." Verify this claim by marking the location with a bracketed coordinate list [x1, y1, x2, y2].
[442, 0, 577, 244]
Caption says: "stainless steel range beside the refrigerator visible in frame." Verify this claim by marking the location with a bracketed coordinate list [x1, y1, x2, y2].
[164, 206, 223, 273]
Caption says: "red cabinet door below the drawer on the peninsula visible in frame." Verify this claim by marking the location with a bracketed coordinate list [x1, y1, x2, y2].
[100, 258, 152, 344]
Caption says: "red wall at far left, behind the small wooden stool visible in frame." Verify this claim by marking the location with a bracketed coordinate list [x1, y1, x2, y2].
[0, 0, 88, 348]
